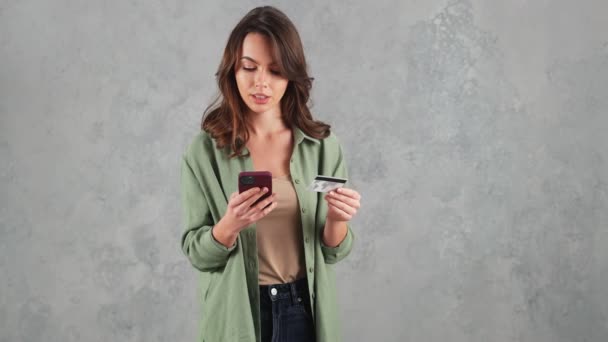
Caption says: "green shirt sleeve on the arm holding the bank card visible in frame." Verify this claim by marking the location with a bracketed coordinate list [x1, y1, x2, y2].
[320, 137, 355, 264]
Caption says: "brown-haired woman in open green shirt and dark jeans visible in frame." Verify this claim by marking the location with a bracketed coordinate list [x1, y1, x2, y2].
[181, 6, 361, 342]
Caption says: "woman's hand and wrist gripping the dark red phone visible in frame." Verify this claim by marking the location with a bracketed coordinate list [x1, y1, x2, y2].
[212, 187, 277, 247]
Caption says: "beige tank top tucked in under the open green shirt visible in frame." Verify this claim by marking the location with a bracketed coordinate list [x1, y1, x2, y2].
[256, 175, 306, 285]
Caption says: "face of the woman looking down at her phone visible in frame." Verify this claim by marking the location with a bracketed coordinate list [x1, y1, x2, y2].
[235, 33, 289, 113]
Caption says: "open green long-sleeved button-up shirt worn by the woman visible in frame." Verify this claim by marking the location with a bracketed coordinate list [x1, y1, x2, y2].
[181, 127, 354, 342]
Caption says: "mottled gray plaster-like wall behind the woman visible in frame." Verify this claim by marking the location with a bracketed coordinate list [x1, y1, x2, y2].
[0, 0, 608, 342]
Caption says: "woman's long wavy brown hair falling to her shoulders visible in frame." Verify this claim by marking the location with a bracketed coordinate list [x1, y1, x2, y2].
[201, 6, 331, 158]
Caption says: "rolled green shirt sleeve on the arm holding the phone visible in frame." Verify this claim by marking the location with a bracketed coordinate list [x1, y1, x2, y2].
[180, 157, 236, 272]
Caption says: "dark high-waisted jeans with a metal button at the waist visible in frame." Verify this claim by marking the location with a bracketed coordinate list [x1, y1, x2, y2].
[260, 278, 315, 342]
